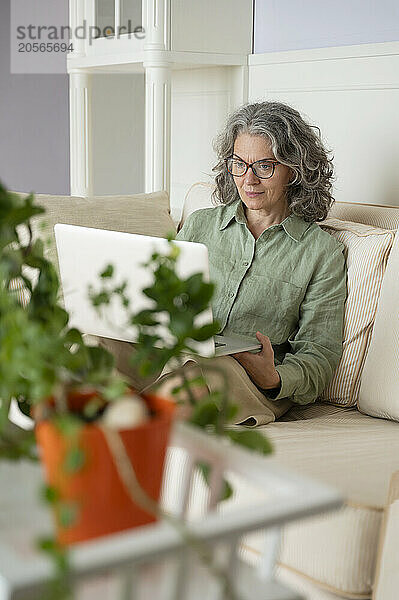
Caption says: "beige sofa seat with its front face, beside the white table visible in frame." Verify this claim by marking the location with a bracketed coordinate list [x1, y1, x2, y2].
[239, 404, 399, 598]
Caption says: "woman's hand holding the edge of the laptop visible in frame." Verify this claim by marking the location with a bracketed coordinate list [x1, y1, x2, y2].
[232, 331, 280, 390]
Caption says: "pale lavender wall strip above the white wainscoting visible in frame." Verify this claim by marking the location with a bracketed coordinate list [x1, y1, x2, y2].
[254, 0, 399, 53]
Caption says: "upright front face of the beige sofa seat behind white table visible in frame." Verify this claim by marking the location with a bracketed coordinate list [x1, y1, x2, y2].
[242, 506, 382, 598]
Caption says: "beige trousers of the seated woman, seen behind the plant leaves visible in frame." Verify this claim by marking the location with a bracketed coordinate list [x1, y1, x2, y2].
[99, 338, 292, 427]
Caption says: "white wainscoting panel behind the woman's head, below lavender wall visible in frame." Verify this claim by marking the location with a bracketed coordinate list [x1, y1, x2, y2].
[249, 42, 399, 206]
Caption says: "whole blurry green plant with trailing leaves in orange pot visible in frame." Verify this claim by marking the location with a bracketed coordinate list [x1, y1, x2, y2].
[0, 184, 270, 596]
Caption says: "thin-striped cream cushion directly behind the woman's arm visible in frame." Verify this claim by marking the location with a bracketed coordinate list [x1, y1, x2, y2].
[321, 218, 395, 406]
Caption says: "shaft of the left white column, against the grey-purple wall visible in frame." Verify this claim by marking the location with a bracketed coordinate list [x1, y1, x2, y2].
[69, 69, 93, 196]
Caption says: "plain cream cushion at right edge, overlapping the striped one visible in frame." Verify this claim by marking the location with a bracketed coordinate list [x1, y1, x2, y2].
[358, 234, 399, 422]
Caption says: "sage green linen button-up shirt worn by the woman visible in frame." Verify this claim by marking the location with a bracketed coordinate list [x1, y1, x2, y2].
[176, 201, 346, 404]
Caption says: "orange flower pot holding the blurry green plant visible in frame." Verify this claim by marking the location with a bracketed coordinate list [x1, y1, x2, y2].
[36, 394, 174, 545]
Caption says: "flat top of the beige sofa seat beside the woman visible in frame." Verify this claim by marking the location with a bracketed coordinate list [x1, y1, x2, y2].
[258, 403, 399, 508]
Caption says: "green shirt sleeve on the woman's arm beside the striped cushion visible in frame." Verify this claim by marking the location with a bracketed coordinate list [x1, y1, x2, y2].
[265, 247, 346, 404]
